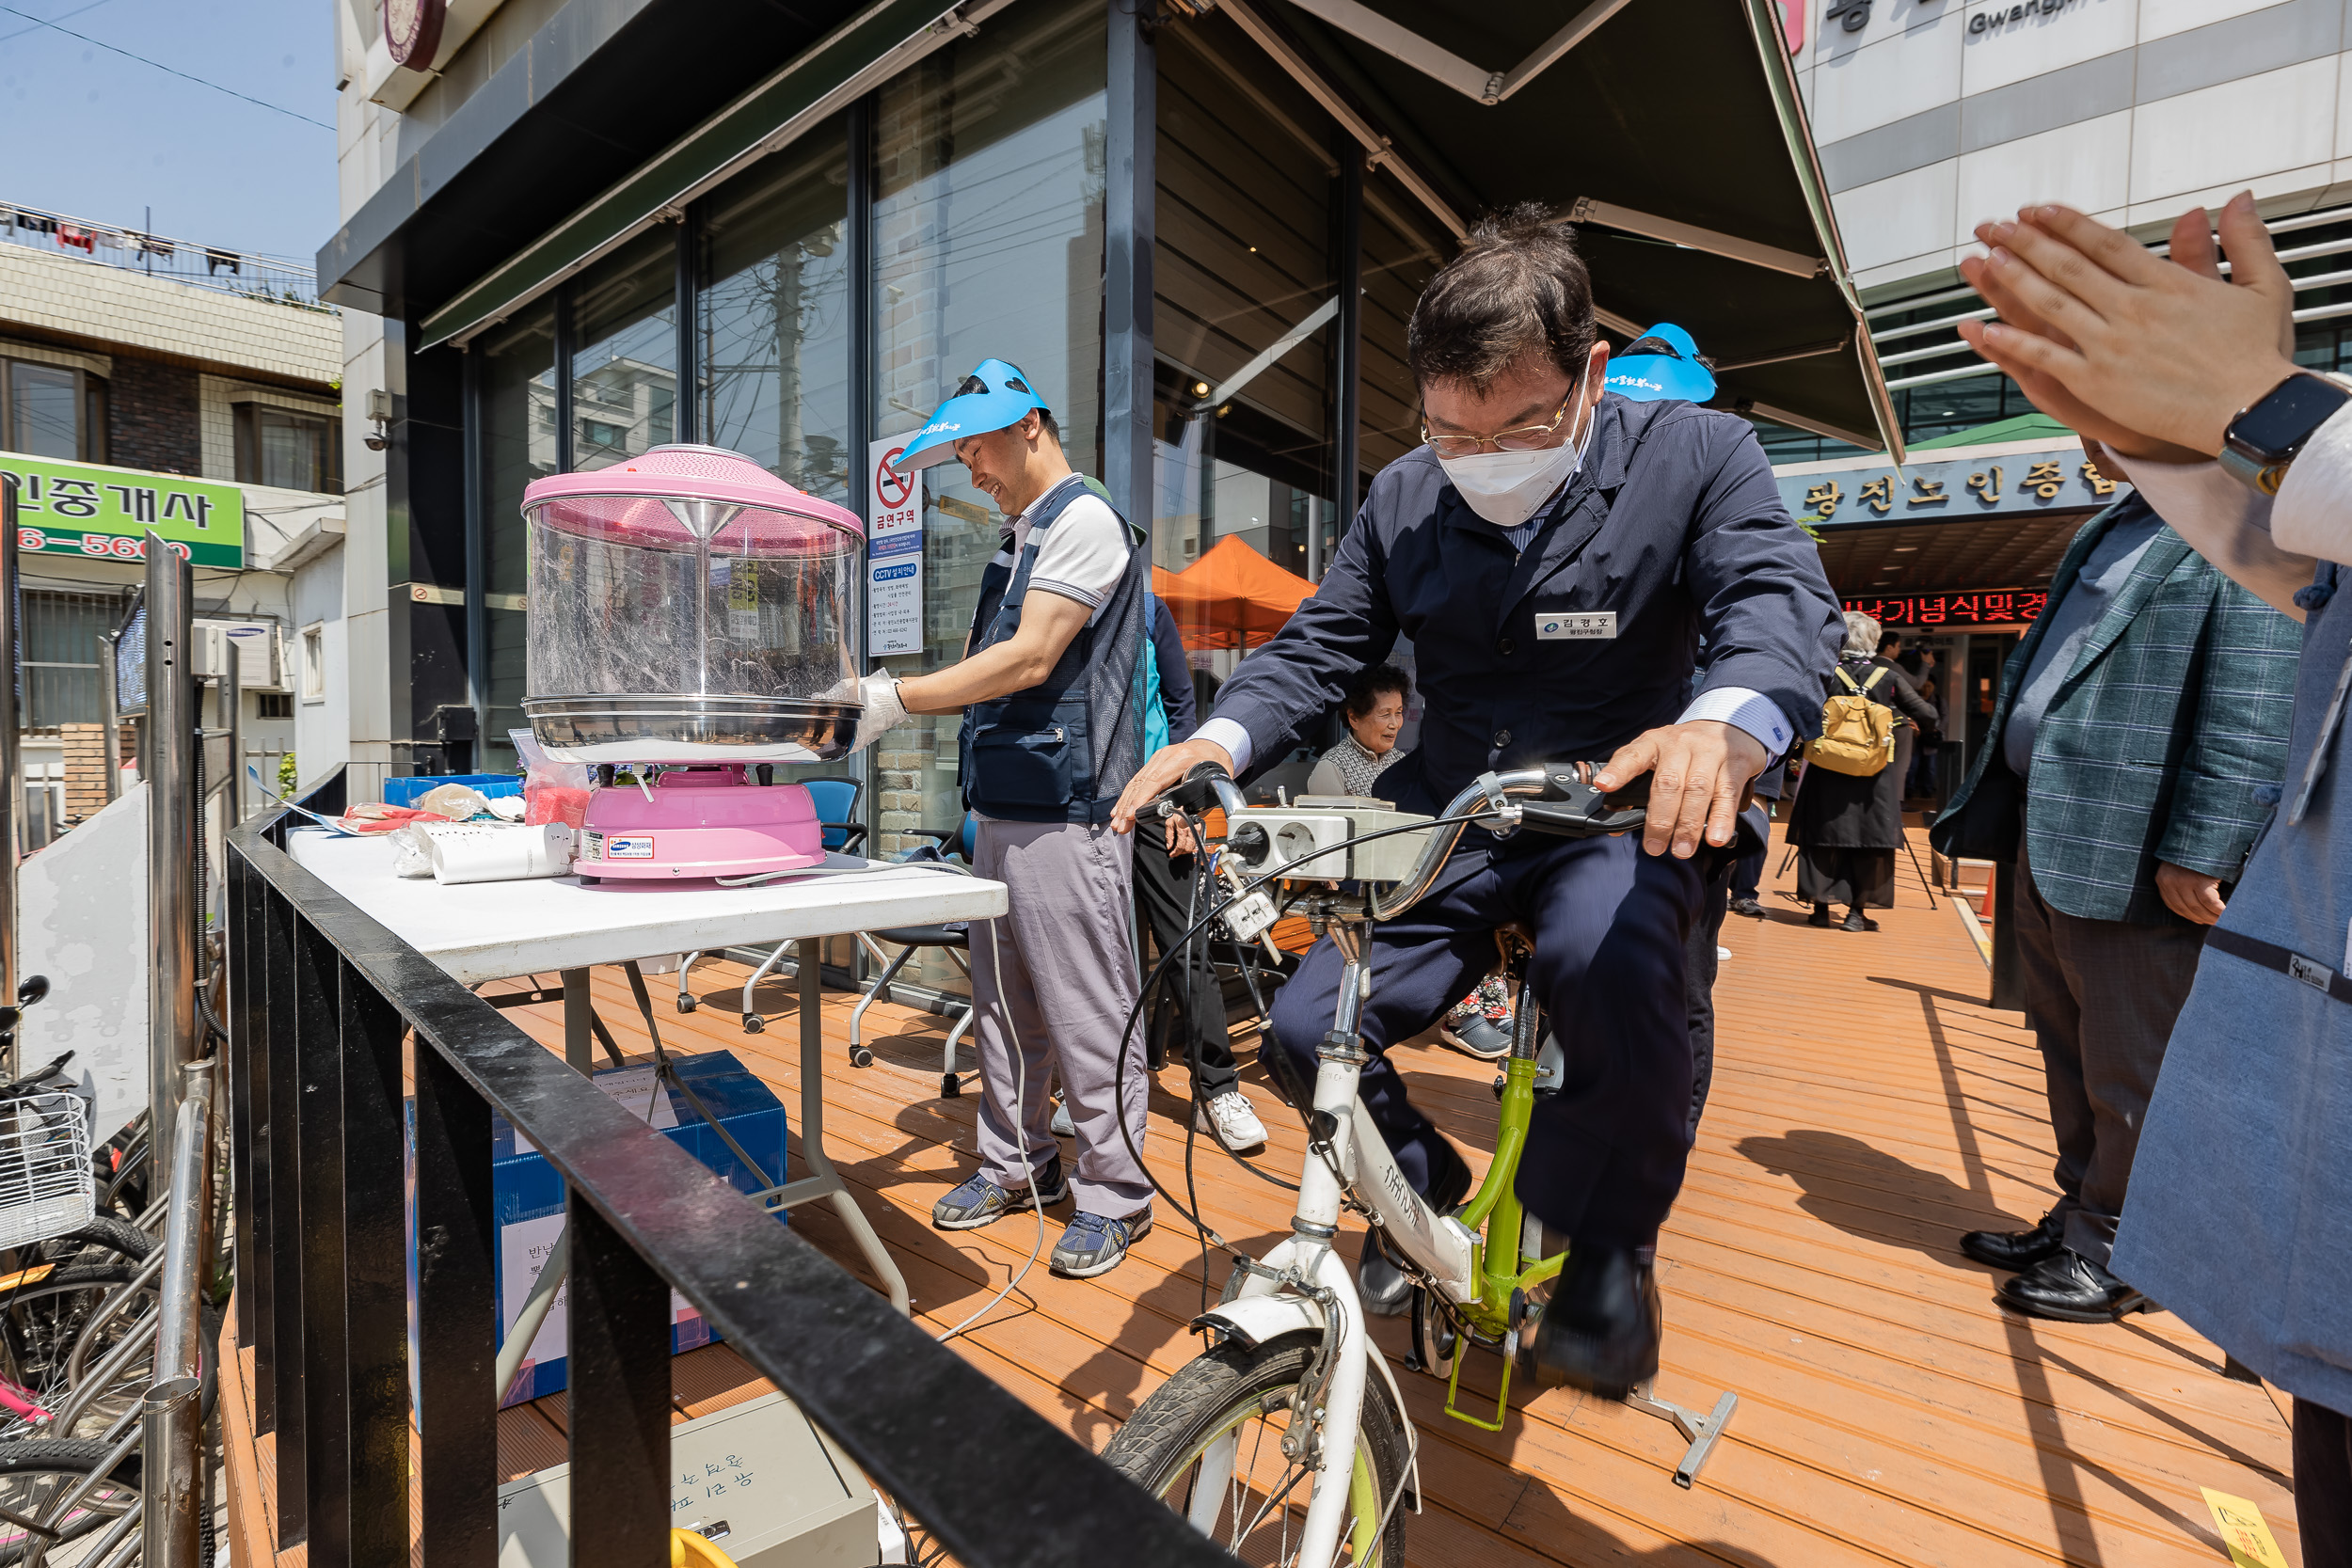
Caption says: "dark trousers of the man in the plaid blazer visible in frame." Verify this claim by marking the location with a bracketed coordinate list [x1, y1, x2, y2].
[2011, 847, 2204, 1267]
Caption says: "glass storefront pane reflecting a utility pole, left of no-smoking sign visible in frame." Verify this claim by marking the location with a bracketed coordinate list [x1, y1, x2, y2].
[696, 122, 851, 505]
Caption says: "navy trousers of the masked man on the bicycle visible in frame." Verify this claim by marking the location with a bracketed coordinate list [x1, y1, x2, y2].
[1273, 830, 1703, 1246]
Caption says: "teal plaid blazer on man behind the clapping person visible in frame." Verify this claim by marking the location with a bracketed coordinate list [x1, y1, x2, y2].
[1933, 496, 2303, 924]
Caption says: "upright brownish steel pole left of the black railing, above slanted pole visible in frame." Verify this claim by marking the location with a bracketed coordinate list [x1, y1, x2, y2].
[146, 529, 198, 1173]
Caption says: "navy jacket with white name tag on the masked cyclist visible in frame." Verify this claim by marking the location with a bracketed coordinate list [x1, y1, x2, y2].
[1216, 392, 1847, 811]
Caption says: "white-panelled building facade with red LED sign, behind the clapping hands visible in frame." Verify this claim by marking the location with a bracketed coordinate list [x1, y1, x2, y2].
[1764, 0, 2352, 784]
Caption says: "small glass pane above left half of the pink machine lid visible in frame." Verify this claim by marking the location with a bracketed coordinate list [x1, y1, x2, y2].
[572, 223, 677, 470]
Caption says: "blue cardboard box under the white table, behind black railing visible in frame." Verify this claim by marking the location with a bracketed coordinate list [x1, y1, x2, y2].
[409, 1051, 790, 1403]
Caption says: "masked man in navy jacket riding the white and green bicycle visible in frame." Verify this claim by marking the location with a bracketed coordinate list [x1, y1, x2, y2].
[1118, 207, 1844, 1397]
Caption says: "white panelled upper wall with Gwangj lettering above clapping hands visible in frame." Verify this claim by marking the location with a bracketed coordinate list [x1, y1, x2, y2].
[1795, 0, 2352, 293]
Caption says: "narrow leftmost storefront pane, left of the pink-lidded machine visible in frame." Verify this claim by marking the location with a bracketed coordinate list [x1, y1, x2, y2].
[473, 301, 558, 771]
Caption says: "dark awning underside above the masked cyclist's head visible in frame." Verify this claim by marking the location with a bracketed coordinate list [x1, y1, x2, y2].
[1218, 0, 1900, 456]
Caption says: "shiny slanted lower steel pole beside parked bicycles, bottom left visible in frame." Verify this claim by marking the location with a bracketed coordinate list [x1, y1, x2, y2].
[139, 1060, 212, 1568]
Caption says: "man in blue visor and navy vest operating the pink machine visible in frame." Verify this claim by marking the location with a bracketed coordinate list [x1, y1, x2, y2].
[859, 359, 1152, 1279]
